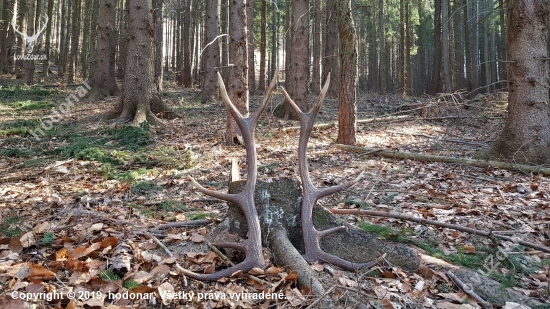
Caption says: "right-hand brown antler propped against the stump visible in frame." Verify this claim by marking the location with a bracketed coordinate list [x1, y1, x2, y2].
[281, 73, 376, 270]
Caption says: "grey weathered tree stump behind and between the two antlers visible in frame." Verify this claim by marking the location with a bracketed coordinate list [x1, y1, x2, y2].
[226, 179, 419, 270]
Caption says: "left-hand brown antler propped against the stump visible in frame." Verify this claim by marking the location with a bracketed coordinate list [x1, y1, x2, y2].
[183, 71, 278, 281]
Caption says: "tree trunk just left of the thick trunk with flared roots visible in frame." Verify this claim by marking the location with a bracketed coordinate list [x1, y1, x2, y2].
[89, 0, 118, 99]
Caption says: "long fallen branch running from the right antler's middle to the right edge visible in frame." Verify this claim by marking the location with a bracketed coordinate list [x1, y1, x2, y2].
[330, 208, 550, 253]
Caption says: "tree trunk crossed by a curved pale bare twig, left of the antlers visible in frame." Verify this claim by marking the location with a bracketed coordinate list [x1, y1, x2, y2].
[201, 0, 220, 103]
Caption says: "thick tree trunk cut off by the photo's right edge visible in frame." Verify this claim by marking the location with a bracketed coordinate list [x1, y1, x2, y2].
[492, 0, 550, 164]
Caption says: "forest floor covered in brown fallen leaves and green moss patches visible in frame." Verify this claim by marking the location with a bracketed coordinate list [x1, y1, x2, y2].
[0, 75, 550, 309]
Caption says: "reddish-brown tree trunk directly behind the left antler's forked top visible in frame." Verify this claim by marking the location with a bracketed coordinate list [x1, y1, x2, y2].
[225, 0, 248, 146]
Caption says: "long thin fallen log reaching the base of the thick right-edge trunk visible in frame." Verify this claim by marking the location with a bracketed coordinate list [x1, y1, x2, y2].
[334, 144, 550, 176]
